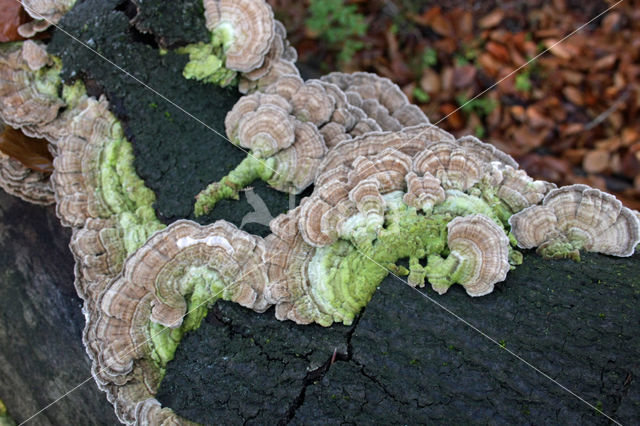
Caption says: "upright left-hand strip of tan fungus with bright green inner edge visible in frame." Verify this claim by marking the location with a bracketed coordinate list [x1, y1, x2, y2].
[52, 83, 164, 250]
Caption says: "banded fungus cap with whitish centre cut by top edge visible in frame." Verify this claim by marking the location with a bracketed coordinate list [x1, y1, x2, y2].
[203, 0, 275, 73]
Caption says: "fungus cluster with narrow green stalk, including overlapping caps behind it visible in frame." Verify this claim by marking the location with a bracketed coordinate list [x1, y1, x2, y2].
[195, 73, 422, 215]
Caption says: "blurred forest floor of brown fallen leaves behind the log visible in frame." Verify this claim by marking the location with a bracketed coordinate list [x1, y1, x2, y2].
[269, 0, 640, 209]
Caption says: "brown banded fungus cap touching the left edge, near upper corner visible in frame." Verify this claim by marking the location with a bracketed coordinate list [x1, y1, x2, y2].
[0, 41, 64, 128]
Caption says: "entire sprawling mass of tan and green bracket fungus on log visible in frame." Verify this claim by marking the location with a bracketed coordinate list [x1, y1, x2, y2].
[0, 0, 640, 424]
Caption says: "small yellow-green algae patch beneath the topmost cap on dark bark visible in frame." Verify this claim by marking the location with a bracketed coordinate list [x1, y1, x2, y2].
[176, 25, 237, 87]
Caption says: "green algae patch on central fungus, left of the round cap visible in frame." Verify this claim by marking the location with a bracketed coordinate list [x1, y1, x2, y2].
[308, 191, 450, 326]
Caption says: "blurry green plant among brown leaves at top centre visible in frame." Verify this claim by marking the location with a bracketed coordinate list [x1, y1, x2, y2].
[305, 0, 368, 64]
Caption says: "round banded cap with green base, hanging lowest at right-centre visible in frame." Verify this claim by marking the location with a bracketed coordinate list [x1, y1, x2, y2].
[427, 214, 509, 296]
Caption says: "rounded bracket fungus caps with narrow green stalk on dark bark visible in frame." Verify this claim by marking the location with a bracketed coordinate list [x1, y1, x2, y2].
[195, 75, 380, 215]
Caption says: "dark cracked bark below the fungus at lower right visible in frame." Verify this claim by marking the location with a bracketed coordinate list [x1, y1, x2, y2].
[163, 246, 640, 424]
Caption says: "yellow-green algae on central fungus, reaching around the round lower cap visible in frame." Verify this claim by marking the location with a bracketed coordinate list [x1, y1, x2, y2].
[301, 190, 522, 326]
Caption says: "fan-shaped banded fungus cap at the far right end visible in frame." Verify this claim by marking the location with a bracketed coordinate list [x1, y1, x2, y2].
[509, 185, 640, 259]
